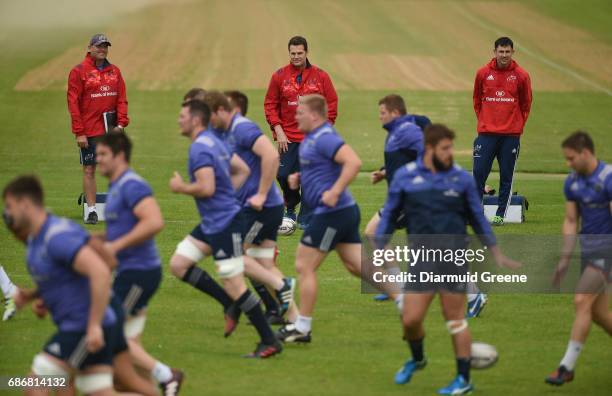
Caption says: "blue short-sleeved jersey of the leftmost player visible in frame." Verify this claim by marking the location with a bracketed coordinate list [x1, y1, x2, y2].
[27, 215, 116, 331]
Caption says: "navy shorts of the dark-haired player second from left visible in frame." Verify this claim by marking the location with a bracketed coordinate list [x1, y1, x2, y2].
[113, 267, 162, 316]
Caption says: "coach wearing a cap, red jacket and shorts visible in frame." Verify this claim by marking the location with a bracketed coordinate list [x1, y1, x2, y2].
[68, 34, 130, 224]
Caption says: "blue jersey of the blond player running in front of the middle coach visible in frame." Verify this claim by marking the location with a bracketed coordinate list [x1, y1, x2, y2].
[300, 122, 355, 214]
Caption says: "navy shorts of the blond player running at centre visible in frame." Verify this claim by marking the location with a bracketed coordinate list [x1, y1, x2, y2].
[300, 204, 361, 252]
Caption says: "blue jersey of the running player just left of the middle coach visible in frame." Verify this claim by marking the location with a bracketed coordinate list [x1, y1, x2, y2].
[225, 114, 283, 208]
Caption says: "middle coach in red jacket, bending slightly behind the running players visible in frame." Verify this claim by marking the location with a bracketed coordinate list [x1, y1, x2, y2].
[264, 36, 338, 227]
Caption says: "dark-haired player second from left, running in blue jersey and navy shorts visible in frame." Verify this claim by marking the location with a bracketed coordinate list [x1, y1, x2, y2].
[96, 133, 183, 394]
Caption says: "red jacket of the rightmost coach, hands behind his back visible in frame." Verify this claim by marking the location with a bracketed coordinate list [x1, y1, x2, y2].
[474, 58, 532, 136]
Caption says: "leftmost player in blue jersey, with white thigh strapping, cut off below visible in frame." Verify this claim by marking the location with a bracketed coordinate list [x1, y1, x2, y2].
[2, 176, 120, 395]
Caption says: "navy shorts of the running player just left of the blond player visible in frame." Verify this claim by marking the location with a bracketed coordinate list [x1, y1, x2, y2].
[242, 205, 285, 245]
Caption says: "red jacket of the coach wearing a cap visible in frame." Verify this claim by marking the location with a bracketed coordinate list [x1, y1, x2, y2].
[67, 54, 130, 137]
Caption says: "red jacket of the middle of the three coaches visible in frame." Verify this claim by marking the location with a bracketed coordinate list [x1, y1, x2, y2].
[264, 61, 338, 142]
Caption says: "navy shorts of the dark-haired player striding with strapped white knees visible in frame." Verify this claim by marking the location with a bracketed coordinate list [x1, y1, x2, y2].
[189, 212, 244, 260]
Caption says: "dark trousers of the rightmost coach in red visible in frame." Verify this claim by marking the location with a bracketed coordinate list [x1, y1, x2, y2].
[473, 133, 521, 217]
